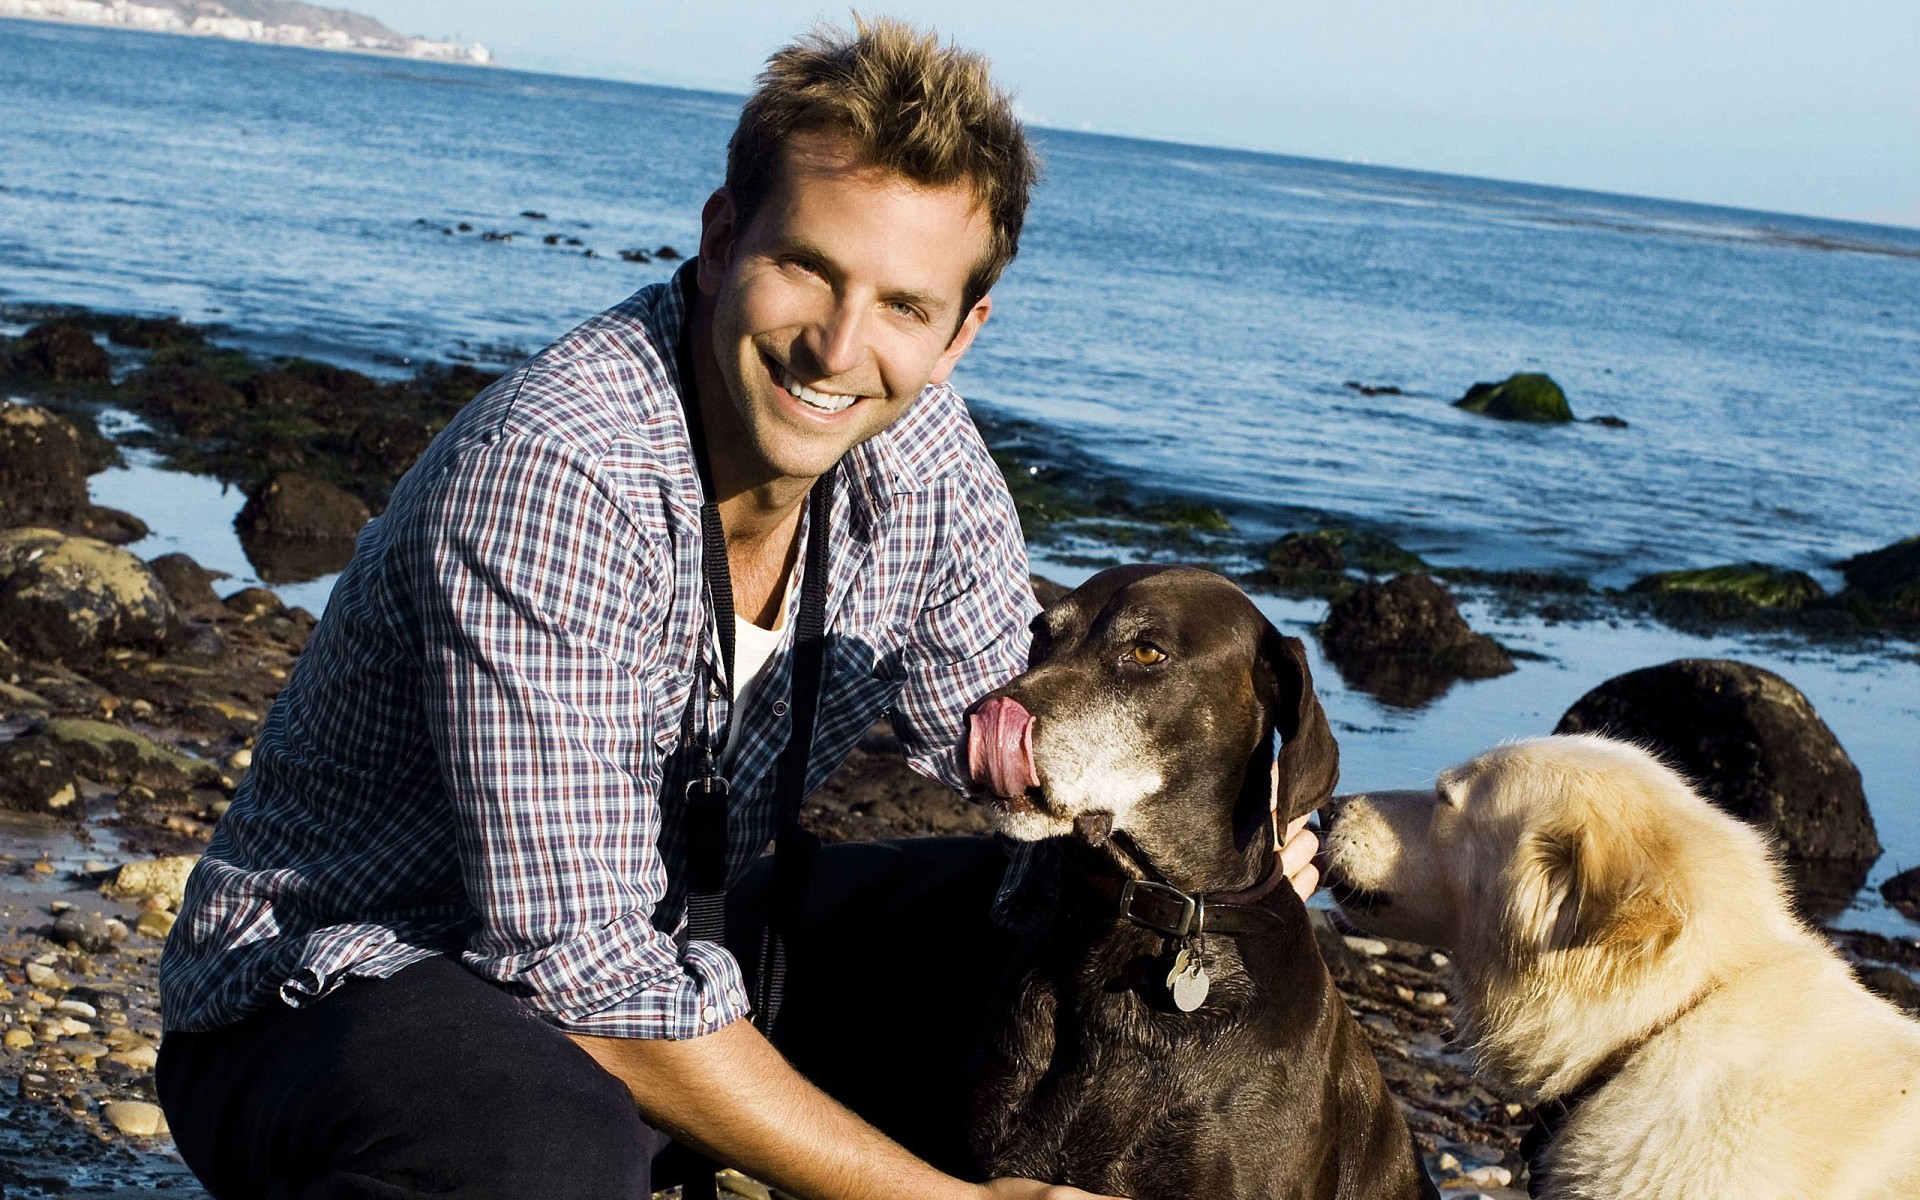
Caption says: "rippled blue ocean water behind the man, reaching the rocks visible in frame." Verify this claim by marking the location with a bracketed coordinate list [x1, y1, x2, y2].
[0, 21, 1920, 933]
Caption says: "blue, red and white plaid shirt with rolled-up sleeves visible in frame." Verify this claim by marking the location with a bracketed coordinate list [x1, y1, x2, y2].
[159, 270, 1035, 1039]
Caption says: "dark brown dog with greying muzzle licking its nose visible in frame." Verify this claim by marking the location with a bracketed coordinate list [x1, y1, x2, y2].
[968, 566, 1438, 1200]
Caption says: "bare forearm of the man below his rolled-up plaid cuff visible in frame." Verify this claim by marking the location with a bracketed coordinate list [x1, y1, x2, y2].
[574, 1021, 981, 1200]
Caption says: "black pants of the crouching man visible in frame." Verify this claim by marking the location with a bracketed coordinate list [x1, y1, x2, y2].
[157, 837, 1012, 1200]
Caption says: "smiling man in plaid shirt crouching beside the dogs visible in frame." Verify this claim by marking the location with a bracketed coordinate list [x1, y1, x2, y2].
[159, 23, 1309, 1200]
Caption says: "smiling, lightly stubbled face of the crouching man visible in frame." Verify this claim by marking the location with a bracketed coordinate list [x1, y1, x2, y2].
[699, 132, 993, 486]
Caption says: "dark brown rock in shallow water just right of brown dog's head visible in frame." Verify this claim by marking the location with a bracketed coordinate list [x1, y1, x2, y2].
[1319, 574, 1513, 708]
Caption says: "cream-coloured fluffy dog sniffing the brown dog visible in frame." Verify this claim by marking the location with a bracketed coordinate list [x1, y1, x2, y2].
[1327, 735, 1920, 1200]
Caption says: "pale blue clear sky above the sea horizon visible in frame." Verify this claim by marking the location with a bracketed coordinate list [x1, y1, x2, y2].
[362, 0, 1920, 227]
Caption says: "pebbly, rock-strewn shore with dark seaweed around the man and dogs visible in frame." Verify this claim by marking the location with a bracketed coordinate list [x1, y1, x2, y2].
[0, 309, 1920, 1196]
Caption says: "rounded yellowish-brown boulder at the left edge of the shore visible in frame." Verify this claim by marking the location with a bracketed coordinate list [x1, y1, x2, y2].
[0, 526, 175, 664]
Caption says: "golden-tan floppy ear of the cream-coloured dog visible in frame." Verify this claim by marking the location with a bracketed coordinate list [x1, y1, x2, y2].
[1505, 817, 1682, 966]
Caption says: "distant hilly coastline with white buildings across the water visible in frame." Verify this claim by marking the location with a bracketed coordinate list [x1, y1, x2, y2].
[0, 0, 499, 67]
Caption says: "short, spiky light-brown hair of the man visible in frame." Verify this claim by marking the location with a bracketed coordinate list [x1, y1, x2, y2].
[726, 15, 1041, 309]
